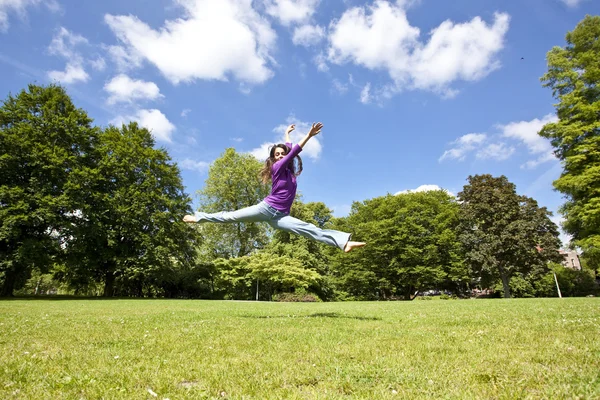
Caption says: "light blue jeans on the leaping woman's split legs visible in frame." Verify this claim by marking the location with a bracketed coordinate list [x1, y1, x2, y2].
[194, 201, 350, 250]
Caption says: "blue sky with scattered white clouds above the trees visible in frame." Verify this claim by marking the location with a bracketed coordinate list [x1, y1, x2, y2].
[0, 0, 600, 247]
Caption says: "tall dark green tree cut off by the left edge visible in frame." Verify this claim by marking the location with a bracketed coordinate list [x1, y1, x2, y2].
[0, 85, 98, 296]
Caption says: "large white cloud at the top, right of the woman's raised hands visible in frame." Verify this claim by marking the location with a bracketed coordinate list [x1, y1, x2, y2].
[328, 0, 510, 97]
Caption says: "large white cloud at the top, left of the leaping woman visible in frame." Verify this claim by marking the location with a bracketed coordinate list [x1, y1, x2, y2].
[104, 0, 276, 84]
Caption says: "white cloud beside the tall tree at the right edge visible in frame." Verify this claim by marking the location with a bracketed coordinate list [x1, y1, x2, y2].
[498, 114, 558, 168]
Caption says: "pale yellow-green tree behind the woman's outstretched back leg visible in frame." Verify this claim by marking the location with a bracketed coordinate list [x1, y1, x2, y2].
[198, 148, 270, 260]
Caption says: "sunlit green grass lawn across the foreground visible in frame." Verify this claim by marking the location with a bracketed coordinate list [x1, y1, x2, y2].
[0, 298, 600, 400]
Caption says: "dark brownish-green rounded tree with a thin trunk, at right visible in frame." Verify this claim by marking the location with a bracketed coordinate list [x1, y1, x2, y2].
[458, 174, 561, 297]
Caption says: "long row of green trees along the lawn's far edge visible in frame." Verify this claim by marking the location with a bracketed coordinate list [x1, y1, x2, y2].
[0, 85, 595, 301]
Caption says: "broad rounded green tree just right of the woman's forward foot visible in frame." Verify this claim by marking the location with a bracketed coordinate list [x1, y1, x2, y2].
[334, 191, 469, 299]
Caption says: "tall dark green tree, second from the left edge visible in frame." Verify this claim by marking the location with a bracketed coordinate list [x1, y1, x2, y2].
[62, 122, 197, 296]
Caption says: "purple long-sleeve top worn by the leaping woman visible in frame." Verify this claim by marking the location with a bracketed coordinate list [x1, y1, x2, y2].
[264, 143, 302, 214]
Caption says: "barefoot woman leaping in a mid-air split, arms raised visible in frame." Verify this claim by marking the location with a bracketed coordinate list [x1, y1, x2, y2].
[183, 122, 365, 252]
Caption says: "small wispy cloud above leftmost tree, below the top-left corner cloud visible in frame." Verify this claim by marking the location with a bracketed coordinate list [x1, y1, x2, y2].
[48, 27, 90, 84]
